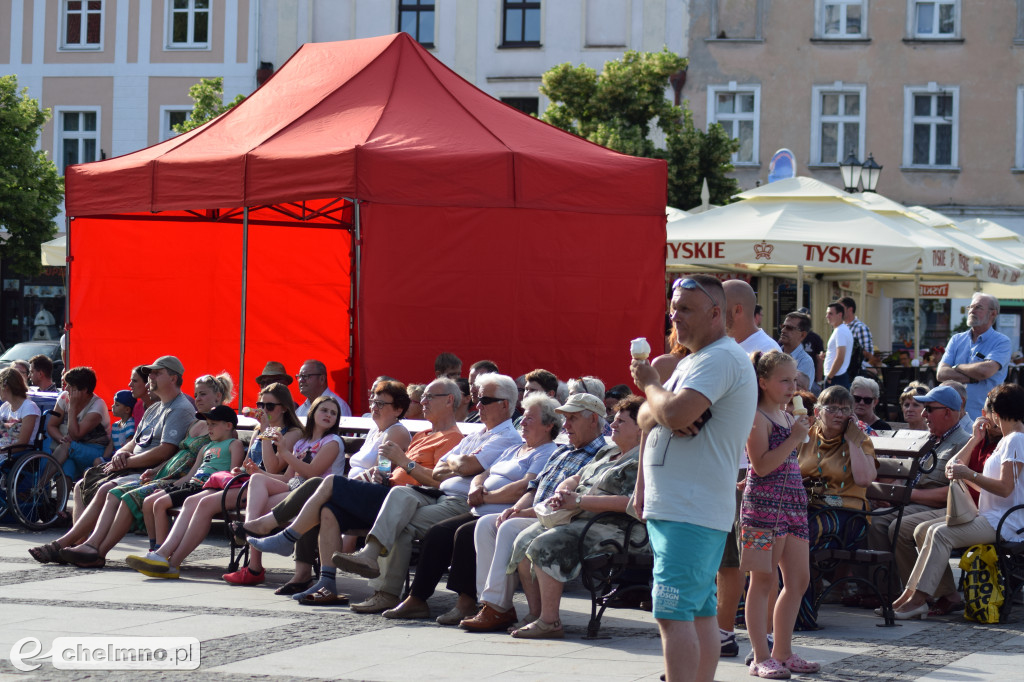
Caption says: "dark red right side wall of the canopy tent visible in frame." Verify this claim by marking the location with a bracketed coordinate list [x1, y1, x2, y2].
[358, 204, 666, 387]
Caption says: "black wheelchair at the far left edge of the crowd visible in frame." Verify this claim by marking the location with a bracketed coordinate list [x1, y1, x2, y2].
[0, 411, 71, 530]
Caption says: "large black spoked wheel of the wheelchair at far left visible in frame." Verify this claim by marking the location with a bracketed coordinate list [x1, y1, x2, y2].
[6, 453, 68, 530]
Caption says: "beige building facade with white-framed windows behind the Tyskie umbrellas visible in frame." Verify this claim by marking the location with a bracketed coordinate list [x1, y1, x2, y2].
[682, 0, 1024, 352]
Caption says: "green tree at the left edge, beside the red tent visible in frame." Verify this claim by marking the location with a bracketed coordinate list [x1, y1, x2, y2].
[0, 76, 63, 276]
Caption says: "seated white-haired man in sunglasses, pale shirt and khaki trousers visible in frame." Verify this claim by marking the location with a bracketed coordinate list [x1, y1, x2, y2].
[332, 374, 522, 613]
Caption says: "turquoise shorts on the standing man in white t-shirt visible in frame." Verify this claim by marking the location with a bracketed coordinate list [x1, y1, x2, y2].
[647, 519, 728, 621]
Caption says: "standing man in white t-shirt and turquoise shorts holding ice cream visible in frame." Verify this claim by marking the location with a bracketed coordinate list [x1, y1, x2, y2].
[630, 274, 757, 680]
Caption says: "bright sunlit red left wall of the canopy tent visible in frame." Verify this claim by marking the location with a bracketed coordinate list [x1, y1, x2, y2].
[69, 214, 351, 406]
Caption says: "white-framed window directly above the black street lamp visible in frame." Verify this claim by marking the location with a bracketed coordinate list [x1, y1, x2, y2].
[811, 83, 867, 165]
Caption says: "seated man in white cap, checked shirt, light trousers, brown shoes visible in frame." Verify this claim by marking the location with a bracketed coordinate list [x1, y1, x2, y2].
[459, 393, 618, 636]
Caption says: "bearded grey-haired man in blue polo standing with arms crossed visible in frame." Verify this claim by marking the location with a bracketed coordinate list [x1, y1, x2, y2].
[938, 294, 1010, 421]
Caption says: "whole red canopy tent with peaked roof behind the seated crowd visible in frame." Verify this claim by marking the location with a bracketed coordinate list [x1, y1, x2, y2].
[66, 34, 666, 408]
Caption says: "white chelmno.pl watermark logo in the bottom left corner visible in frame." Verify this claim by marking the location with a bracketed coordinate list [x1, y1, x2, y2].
[10, 637, 200, 673]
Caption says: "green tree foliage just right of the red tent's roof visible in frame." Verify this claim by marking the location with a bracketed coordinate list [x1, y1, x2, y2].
[541, 48, 739, 208]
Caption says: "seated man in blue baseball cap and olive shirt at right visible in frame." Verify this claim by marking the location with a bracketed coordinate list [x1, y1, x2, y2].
[867, 386, 971, 612]
